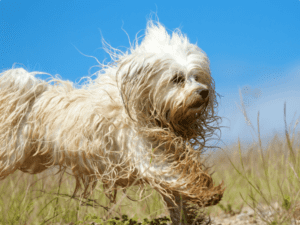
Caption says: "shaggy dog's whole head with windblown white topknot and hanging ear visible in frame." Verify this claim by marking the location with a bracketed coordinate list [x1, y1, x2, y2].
[112, 21, 217, 148]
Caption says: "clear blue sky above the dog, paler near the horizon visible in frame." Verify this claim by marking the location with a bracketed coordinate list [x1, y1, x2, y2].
[0, 0, 300, 149]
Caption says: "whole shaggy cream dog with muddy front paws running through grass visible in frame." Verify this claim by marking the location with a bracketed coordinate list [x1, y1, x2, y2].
[0, 21, 224, 224]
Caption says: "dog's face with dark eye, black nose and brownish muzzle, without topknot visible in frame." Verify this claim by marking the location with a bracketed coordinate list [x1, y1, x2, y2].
[149, 58, 215, 138]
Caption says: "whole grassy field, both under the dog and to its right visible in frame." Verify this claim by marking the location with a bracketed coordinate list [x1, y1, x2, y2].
[0, 103, 300, 225]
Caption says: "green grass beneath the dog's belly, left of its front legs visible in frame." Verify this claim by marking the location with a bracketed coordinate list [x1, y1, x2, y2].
[0, 168, 167, 224]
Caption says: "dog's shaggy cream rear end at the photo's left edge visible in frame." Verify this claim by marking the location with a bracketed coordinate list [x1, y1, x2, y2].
[0, 68, 49, 179]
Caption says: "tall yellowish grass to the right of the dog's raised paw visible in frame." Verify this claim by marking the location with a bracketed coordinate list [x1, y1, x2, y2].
[208, 101, 300, 225]
